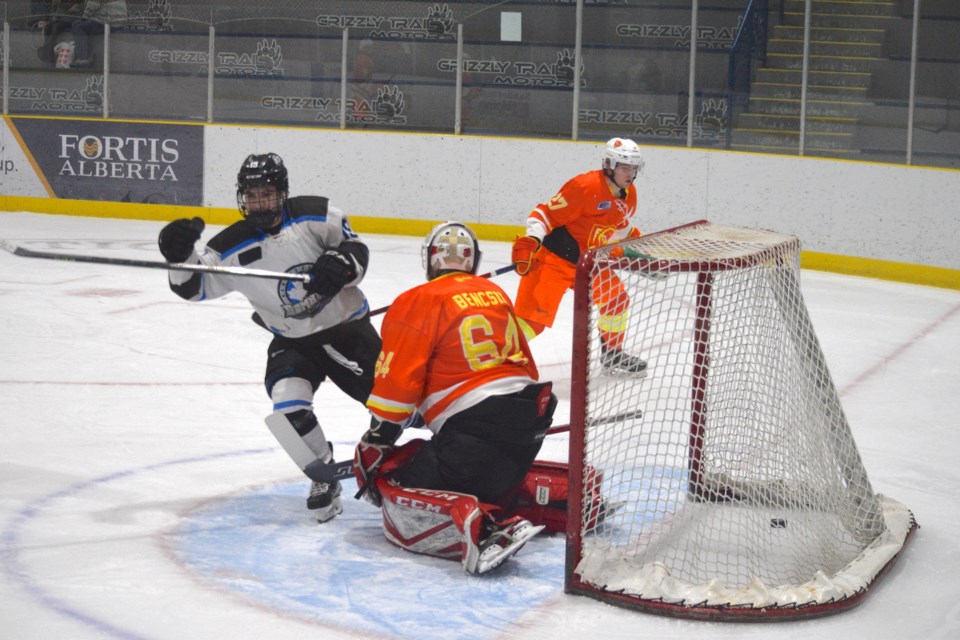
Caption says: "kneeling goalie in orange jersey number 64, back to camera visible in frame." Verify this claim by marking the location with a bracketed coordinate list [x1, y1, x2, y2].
[354, 222, 565, 573]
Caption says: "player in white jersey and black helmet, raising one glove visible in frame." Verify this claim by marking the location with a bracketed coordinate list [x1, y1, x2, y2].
[159, 153, 381, 522]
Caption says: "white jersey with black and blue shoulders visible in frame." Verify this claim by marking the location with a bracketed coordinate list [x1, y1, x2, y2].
[169, 196, 370, 338]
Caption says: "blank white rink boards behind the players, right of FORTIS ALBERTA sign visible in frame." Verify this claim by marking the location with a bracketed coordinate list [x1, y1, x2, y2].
[204, 125, 960, 269]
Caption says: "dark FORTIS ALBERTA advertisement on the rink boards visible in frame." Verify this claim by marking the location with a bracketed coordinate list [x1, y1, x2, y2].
[7, 118, 203, 206]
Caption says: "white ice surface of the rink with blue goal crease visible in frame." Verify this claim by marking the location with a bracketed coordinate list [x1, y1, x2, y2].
[0, 213, 960, 640]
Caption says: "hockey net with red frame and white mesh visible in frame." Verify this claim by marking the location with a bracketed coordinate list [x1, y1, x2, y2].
[566, 221, 917, 620]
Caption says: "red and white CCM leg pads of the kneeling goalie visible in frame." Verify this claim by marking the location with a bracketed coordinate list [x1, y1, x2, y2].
[354, 439, 607, 574]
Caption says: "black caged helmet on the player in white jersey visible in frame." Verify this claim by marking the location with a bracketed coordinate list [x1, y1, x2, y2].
[237, 153, 290, 230]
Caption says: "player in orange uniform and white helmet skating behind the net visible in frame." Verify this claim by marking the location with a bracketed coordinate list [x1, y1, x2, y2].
[512, 138, 647, 377]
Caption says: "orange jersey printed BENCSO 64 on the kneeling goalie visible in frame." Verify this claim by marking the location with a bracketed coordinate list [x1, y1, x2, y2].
[367, 273, 539, 433]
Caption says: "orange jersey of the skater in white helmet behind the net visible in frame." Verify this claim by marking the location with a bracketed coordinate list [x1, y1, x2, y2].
[527, 169, 640, 262]
